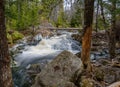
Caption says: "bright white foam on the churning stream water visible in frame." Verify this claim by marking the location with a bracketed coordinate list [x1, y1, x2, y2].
[15, 33, 79, 65]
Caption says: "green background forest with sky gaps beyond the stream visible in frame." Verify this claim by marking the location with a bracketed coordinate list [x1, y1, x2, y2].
[5, 0, 120, 30]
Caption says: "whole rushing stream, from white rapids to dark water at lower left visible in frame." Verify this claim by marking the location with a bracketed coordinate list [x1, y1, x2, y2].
[10, 31, 111, 87]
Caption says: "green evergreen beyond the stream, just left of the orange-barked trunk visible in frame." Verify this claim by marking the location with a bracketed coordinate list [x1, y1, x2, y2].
[70, 0, 84, 27]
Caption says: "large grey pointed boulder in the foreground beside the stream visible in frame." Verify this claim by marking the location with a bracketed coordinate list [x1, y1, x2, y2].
[32, 51, 83, 87]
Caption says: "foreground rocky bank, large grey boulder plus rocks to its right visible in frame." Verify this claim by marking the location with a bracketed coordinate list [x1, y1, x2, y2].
[28, 51, 120, 87]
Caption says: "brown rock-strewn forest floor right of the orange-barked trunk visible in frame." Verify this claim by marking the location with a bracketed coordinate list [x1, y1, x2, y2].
[82, 31, 120, 87]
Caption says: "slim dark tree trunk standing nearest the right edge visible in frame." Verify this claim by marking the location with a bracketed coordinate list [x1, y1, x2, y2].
[109, 0, 116, 59]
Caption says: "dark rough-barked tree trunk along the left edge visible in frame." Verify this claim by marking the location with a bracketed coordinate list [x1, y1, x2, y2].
[0, 0, 13, 87]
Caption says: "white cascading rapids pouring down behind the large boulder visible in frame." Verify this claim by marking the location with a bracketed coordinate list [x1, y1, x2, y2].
[12, 32, 81, 66]
